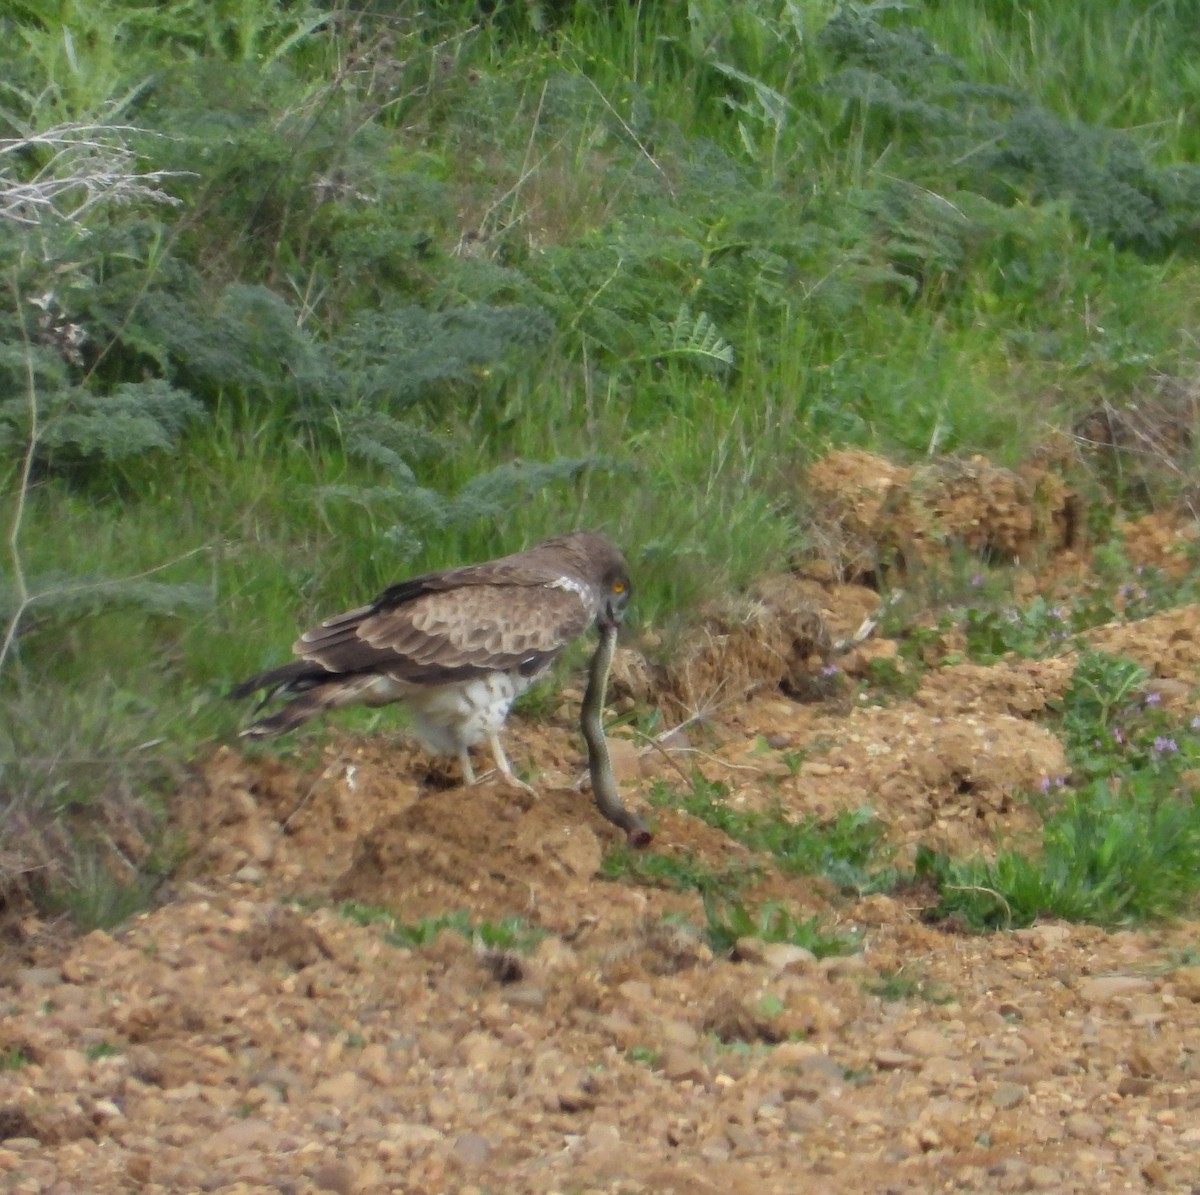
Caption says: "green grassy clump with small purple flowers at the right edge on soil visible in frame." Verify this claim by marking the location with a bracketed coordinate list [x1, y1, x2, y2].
[917, 651, 1200, 929]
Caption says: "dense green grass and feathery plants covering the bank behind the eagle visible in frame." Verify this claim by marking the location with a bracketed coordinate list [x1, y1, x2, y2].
[7, 0, 1200, 925]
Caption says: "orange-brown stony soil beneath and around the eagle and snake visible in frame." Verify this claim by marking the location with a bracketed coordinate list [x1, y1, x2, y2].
[0, 453, 1200, 1195]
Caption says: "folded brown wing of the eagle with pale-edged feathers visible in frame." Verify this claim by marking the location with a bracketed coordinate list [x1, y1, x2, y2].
[292, 578, 596, 684]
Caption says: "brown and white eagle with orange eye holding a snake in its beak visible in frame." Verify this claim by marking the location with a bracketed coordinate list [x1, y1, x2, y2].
[230, 532, 630, 785]
